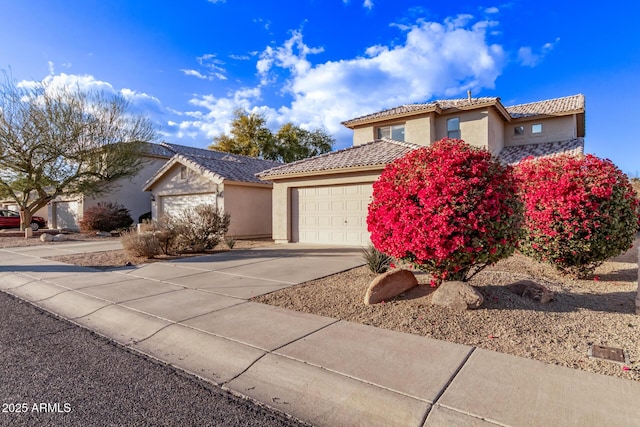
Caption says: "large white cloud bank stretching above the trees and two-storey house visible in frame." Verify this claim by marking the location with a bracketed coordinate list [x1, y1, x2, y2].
[170, 15, 505, 147]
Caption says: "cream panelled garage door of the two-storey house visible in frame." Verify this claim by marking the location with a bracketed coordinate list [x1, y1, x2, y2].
[291, 184, 373, 246]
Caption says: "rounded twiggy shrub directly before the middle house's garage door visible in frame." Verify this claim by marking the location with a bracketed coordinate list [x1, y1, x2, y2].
[168, 204, 231, 253]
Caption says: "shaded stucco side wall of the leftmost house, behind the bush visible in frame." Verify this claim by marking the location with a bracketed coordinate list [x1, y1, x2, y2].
[85, 158, 167, 223]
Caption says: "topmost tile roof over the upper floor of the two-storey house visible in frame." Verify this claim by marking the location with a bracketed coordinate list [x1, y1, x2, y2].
[342, 94, 584, 127]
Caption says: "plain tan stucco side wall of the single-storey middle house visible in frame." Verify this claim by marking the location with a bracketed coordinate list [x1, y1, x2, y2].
[223, 184, 272, 238]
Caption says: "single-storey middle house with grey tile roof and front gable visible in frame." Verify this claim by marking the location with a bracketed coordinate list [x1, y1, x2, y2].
[143, 143, 282, 238]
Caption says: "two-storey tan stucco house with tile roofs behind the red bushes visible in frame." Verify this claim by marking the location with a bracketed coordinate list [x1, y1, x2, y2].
[258, 95, 585, 246]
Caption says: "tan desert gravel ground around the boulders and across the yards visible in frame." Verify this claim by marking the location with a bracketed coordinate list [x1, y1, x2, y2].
[0, 235, 640, 381]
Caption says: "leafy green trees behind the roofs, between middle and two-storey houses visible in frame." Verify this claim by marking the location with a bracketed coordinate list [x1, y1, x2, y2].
[209, 109, 334, 163]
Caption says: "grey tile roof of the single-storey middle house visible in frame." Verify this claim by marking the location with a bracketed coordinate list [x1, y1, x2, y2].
[161, 142, 283, 184]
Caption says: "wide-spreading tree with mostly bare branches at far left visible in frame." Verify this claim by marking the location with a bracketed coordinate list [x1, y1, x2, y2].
[0, 73, 155, 229]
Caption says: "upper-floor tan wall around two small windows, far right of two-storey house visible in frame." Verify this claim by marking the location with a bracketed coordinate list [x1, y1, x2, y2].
[504, 115, 577, 146]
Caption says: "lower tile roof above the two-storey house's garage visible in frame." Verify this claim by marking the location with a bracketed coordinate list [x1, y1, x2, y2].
[258, 138, 420, 179]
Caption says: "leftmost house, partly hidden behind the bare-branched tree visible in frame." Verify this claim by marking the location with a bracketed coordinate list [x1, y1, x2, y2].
[47, 143, 175, 231]
